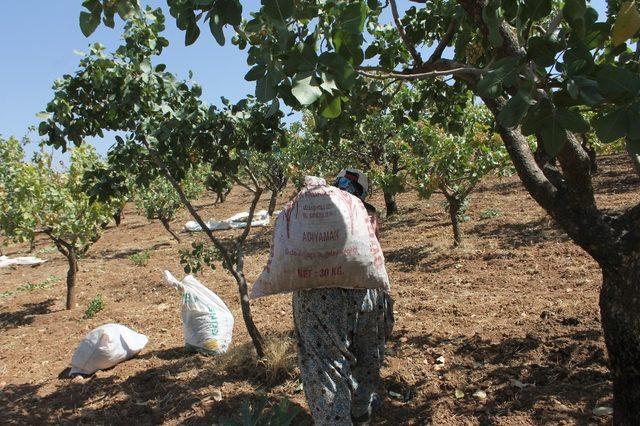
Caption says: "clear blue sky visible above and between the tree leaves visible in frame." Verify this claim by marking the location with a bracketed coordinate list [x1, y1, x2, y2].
[0, 0, 605, 160]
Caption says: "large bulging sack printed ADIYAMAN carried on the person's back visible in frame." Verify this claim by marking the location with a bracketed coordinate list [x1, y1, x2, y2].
[251, 176, 389, 299]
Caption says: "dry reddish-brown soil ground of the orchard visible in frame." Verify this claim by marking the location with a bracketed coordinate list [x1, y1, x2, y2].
[0, 156, 640, 425]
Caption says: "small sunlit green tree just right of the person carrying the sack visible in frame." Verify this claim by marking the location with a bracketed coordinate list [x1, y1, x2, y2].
[409, 103, 511, 246]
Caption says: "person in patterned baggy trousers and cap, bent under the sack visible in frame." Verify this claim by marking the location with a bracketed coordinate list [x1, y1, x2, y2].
[293, 169, 393, 425]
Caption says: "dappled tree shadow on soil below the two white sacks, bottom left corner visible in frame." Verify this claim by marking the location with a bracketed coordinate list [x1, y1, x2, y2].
[0, 332, 310, 425]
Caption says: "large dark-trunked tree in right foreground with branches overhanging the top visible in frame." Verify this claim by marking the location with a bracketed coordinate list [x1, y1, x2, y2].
[80, 0, 640, 416]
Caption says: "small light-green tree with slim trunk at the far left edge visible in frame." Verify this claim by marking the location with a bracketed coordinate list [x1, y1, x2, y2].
[0, 145, 119, 309]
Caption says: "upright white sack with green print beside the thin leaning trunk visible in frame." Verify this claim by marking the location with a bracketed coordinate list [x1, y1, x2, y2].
[164, 271, 233, 354]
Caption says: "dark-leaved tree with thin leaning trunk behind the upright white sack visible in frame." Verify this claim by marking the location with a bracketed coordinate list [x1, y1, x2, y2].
[39, 8, 282, 357]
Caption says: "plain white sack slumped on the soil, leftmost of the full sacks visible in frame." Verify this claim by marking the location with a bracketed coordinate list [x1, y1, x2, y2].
[69, 324, 149, 376]
